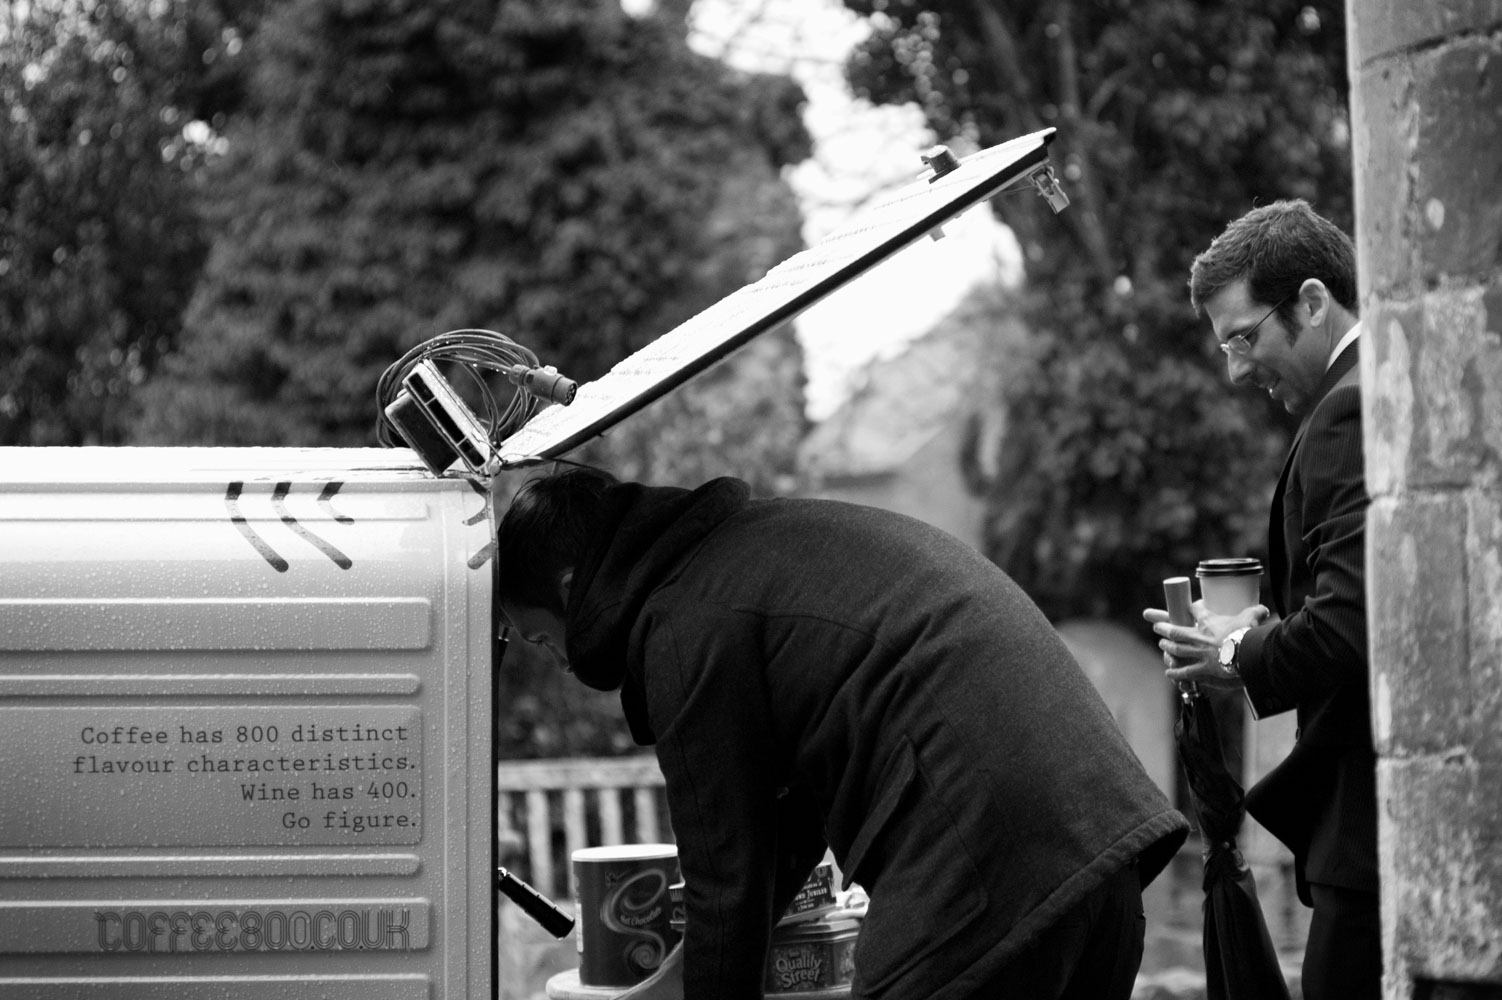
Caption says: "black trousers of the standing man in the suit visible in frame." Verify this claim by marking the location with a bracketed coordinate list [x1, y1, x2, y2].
[1302, 881, 1382, 1000]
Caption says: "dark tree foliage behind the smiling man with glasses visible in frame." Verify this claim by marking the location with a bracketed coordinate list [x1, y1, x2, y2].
[846, 0, 1352, 619]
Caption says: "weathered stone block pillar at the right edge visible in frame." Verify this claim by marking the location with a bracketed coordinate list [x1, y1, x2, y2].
[1346, 0, 1502, 1000]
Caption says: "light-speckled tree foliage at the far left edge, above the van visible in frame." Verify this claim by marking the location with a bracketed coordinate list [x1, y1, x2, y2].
[0, 2, 184, 444]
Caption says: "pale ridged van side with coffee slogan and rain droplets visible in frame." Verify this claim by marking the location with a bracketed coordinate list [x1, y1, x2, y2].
[0, 449, 494, 1000]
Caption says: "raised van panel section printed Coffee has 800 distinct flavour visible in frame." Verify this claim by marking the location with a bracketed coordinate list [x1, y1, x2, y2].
[0, 706, 422, 847]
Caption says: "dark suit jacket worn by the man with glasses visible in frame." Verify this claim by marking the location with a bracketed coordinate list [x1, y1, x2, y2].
[1238, 339, 1377, 902]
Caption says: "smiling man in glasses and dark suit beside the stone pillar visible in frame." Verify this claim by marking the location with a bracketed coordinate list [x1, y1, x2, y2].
[1145, 201, 1382, 1000]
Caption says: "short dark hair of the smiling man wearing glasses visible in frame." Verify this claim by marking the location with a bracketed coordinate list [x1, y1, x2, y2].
[1190, 198, 1356, 329]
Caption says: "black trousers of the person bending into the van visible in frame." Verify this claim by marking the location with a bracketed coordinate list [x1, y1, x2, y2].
[973, 862, 1148, 1000]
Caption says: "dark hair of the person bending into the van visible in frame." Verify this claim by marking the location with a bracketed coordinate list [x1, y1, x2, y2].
[496, 465, 619, 614]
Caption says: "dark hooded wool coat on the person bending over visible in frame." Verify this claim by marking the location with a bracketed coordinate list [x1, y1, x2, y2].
[566, 479, 1188, 1000]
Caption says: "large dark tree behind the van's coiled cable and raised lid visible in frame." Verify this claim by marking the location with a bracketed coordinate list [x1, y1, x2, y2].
[127, 0, 808, 480]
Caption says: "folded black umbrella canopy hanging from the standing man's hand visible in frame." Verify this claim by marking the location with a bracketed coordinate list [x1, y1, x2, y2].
[1173, 689, 1289, 1000]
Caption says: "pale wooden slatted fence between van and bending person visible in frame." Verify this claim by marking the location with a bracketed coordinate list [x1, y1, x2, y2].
[496, 755, 673, 902]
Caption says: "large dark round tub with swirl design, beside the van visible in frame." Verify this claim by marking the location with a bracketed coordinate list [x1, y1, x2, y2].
[572, 844, 679, 986]
